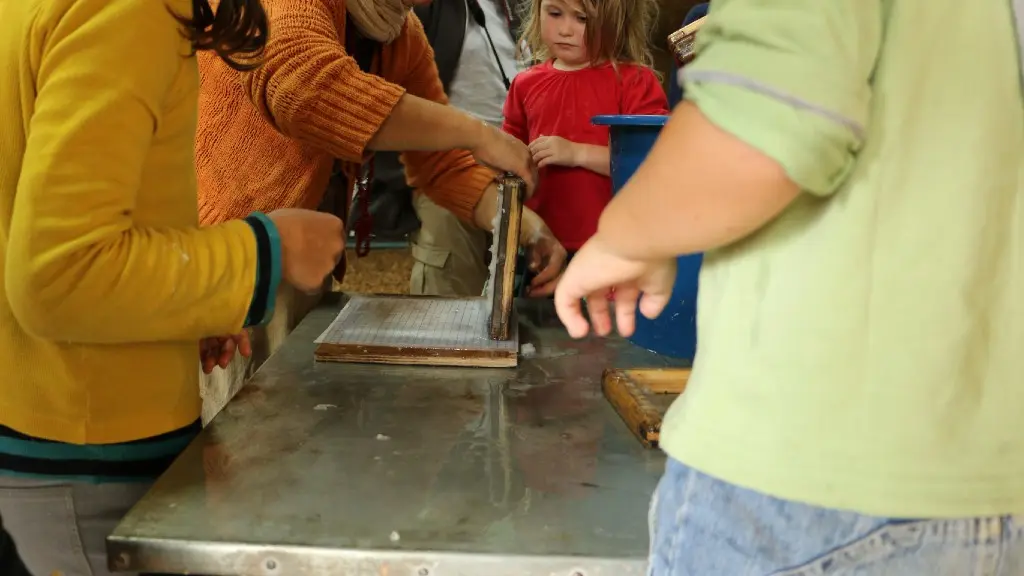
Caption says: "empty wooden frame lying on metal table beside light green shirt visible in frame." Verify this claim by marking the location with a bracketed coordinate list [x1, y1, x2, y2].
[601, 368, 690, 448]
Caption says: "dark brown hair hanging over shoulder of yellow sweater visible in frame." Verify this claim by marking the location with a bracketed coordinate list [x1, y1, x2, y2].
[175, 0, 268, 70]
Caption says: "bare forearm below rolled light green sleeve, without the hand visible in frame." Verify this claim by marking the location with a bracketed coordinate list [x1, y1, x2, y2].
[598, 102, 800, 259]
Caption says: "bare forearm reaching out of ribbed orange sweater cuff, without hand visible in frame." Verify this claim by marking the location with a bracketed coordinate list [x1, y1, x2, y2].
[367, 93, 487, 152]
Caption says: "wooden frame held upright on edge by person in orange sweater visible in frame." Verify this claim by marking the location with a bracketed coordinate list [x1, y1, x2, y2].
[487, 174, 526, 340]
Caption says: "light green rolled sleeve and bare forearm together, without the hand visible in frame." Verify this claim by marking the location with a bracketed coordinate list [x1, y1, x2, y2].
[598, 0, 883, 259]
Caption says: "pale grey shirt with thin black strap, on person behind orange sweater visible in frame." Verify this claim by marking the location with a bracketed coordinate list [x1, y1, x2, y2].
[447, 0, 519, 126]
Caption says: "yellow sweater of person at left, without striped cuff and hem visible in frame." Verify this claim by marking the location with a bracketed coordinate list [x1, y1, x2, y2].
[0, 0, 264, 444]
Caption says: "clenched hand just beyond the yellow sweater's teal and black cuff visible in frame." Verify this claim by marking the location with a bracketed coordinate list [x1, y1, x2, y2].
[267, 208, 345, 293]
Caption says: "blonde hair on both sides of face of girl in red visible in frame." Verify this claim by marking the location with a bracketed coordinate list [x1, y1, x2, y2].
[522, 0, 657, 69]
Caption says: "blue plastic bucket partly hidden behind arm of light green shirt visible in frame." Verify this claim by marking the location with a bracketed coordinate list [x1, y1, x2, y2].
[593, 116, 702, 360]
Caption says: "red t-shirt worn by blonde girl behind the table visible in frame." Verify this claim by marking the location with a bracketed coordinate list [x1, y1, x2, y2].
[504, 61, 669, 250]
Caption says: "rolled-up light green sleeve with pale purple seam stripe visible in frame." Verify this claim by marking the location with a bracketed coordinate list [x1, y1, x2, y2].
[679, 0, 883, 196]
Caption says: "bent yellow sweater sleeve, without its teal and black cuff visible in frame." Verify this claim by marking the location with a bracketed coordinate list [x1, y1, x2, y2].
[3, 0, 257, 343]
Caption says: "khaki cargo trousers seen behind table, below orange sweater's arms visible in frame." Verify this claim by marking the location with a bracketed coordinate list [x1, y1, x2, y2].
[410, 194, 490, 296]
